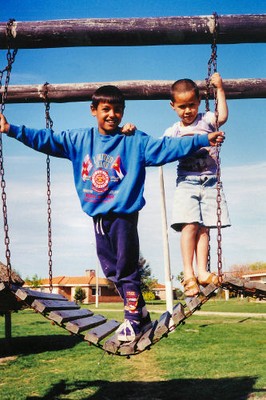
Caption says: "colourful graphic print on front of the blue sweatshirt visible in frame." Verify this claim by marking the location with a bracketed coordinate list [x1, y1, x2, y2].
[81, 153, 126, 203]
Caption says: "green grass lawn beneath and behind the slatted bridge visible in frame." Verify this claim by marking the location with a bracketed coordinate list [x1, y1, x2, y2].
[0, 300, 266, 400]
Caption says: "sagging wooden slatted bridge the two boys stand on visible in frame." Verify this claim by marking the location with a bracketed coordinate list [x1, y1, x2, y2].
[0, 280, 266, 357]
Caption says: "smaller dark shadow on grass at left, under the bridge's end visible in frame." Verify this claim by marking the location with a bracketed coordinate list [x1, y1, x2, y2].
[0, 335, 81, 357]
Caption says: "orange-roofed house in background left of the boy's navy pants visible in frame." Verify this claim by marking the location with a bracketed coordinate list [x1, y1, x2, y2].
[23, 269, 122, 304]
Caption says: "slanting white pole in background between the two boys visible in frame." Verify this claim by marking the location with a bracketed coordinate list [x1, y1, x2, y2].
[159, 167, 173, 314]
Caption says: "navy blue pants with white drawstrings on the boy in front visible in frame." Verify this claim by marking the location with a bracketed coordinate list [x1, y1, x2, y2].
[93, 212, 145, 321]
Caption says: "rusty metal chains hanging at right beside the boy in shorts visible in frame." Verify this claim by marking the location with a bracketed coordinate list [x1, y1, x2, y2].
[206, 13, 222, 282]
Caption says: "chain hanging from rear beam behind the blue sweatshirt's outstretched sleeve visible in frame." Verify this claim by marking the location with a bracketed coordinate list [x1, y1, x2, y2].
[44, 82, 53, 293]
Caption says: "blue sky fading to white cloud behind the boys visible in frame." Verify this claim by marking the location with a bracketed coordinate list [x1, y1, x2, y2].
[0, 0, 266, 282]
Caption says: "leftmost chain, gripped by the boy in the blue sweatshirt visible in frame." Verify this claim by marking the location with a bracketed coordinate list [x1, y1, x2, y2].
[0, 19, 17, 285]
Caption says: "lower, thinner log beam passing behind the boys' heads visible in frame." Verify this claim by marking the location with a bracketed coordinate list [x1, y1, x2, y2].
[0, 78, 266, 103]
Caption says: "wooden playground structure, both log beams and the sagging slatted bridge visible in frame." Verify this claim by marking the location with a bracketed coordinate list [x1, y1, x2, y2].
[0, 15, 266, 356]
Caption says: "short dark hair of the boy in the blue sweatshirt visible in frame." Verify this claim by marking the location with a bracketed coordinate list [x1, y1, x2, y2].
[92, 85, 125, 108]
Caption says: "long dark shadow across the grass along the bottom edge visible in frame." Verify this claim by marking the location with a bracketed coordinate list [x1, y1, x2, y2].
[26, 376, 266, 400]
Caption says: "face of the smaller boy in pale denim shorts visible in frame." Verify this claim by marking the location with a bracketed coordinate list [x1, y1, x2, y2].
[170, 90, 200, 126]
